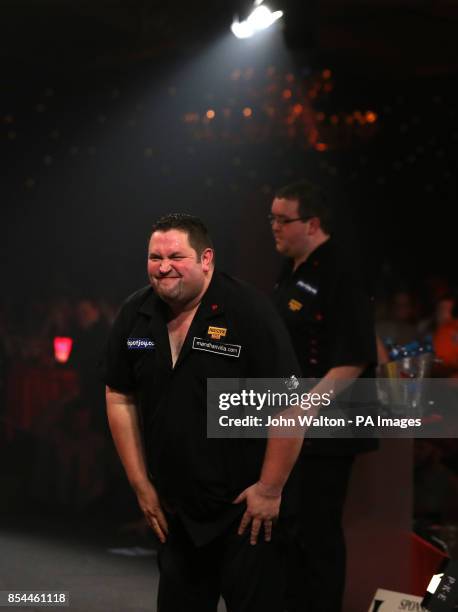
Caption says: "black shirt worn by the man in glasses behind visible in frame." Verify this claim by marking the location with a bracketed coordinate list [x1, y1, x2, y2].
[273, 239, 377, 454]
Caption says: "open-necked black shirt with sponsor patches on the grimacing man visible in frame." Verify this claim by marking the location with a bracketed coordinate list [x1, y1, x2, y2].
[104, 271, 299, 544]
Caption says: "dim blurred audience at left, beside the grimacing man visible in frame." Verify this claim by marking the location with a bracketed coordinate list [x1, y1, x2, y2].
[0, 296, 121, 512]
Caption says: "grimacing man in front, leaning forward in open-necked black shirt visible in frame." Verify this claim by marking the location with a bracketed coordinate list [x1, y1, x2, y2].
[104, 215, 301, 612]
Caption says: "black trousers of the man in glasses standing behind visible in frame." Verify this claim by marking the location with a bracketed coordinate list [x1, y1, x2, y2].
[283, 455, 353, 612]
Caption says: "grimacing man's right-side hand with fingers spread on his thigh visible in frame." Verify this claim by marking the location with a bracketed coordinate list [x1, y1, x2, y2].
[232, 482, 281, 544]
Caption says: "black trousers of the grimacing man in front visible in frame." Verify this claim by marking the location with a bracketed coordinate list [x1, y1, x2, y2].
[157, 518, 285, 612]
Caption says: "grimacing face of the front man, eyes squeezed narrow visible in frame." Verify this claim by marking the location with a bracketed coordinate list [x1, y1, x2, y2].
[148, 229, 212, 305]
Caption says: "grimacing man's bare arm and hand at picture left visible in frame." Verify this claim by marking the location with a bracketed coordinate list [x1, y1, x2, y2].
[106, 387, 168, 542]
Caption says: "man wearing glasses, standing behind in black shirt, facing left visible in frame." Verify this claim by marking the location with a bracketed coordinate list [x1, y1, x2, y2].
[269, 180, 376, 612]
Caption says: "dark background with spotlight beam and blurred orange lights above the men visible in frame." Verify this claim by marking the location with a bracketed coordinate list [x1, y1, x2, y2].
[0, 2, 458, 300]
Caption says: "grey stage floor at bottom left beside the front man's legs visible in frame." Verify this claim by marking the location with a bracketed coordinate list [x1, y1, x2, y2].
[0, 517, 225, 612]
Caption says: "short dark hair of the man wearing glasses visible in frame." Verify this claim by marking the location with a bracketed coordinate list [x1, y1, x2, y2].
[275, 179, 333, 232]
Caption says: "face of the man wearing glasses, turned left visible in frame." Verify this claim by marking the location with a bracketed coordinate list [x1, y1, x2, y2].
[272, 198, 309, 257]
